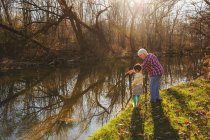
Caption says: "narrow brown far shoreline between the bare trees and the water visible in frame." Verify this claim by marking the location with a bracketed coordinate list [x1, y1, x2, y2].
[0, 52, 210, 71]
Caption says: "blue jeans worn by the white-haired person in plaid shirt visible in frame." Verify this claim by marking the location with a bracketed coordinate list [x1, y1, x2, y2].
[150, 75, 161, 102]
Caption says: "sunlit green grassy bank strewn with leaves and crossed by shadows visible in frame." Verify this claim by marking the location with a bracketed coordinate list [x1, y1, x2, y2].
[89, 80, 210, 140]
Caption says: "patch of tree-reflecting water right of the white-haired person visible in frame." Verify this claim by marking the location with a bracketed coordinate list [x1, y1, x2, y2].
[160, 55, 200, 88]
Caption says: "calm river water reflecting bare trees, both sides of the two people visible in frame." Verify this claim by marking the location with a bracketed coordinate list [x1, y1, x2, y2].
[0, 54, 200, 139]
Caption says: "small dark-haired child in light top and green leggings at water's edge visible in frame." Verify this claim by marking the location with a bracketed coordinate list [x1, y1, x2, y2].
[128, 64, 143, 107]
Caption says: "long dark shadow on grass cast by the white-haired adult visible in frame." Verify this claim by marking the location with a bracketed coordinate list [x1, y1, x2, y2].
[151, 102, 179, 140]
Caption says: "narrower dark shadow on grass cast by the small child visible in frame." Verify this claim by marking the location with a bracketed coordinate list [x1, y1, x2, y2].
[130, 107, 144, 140]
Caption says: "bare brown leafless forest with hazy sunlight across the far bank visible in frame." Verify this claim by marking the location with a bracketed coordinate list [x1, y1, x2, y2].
[0, 0, 210, 64]
